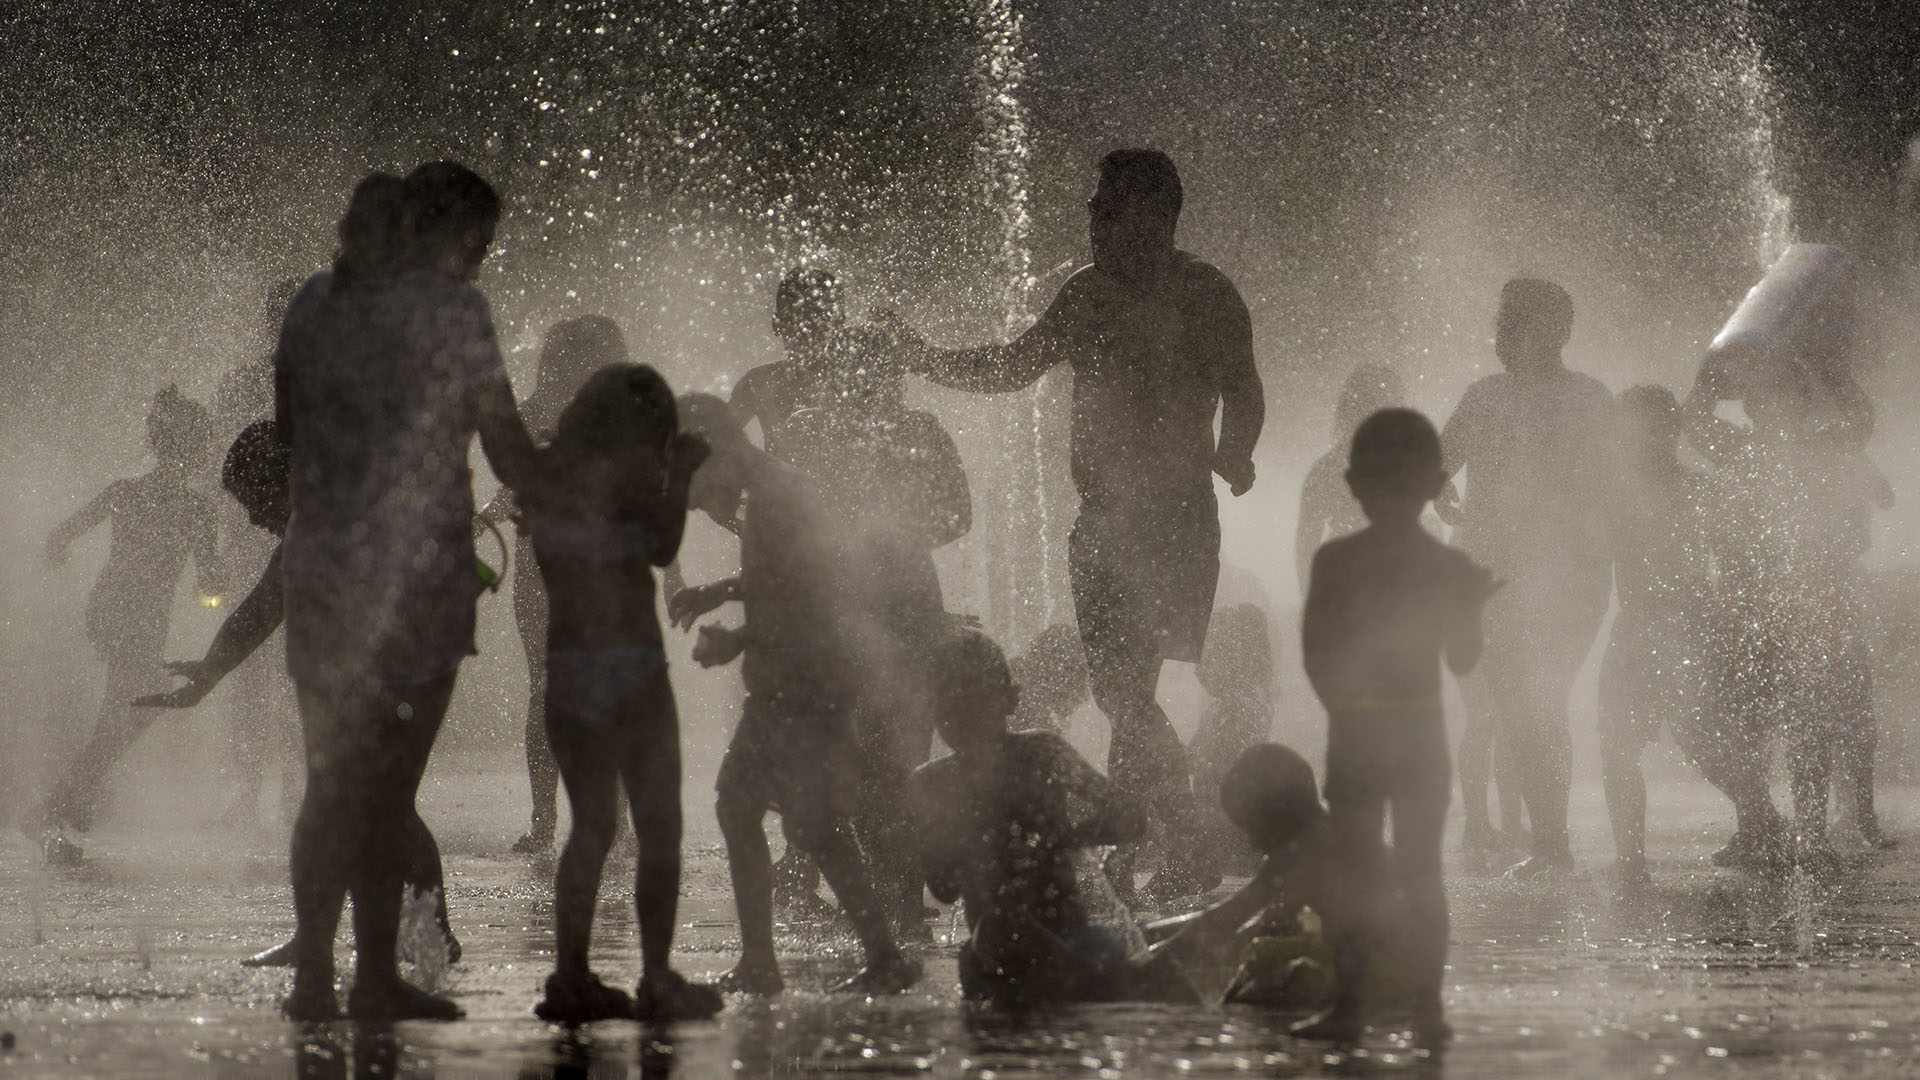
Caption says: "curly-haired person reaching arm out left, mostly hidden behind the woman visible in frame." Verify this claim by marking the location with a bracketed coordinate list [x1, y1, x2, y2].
[134, 421, 461, 967]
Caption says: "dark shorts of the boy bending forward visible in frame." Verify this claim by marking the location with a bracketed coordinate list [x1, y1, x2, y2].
[714, 694, 860, 819]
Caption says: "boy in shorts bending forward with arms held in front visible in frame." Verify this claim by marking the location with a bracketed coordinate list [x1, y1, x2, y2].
[666, 394, 920, 994]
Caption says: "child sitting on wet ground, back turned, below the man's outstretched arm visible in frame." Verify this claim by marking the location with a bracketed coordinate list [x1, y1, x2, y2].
[908, 630, 1192, 1007]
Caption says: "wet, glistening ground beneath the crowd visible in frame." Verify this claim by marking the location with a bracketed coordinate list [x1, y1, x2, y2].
[0, 774, 1920, 1080]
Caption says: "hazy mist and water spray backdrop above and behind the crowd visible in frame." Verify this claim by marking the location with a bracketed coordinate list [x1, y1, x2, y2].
[0, 0, 1920, 815]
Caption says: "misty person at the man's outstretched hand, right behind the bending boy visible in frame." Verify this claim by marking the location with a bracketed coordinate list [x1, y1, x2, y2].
[781, 327, 973, 936]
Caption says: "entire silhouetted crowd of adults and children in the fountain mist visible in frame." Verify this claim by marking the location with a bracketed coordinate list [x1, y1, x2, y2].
[31, 150, 1891, 1049]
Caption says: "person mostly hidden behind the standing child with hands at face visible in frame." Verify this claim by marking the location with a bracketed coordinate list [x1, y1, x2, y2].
[480, 315, 626, 855]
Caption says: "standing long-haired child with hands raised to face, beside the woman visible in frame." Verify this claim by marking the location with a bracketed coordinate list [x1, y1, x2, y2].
[520, 363, 720, 1022]
